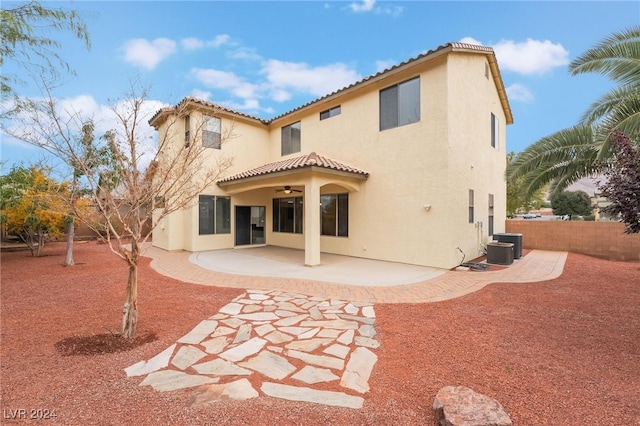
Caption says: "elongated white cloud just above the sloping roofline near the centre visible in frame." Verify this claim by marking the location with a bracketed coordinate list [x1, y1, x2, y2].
[261, 59, 362, 96]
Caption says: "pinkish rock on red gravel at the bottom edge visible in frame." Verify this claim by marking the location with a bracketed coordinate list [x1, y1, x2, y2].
[433, 386, 513, 426]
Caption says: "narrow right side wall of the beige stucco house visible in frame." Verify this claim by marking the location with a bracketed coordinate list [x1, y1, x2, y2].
[447, 54, 506, 266]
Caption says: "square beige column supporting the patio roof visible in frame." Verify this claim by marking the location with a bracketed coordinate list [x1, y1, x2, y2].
[304, 176, 320, 266]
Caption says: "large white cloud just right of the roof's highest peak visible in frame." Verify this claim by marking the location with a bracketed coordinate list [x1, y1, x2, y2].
[460, 37, 569, 75]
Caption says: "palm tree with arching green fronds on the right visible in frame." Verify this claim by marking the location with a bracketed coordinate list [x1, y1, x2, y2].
[507, 26, 640, 198]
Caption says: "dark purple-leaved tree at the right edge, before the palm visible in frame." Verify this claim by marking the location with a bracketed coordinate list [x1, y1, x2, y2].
[598, 135, 640, 234]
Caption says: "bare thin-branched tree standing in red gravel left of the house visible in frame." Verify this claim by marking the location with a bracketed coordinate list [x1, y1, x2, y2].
[5, 80, 235, 338]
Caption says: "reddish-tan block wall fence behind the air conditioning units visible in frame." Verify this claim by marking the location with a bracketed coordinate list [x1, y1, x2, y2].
[505, 220, 640, 261]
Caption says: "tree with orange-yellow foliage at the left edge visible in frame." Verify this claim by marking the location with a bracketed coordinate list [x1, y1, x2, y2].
[0, 165, 69, 256]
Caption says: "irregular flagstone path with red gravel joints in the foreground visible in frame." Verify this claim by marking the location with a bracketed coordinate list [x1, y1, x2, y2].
[125, 290, 380, 408]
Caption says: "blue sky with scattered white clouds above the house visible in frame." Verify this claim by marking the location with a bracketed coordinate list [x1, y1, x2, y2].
[1, 0, 640, 166]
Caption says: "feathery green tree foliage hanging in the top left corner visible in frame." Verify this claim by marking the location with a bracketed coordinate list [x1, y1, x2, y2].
[0, 1, 91, 97]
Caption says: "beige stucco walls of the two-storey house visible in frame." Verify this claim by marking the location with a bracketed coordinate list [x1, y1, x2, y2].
[154, 53, 506, 268]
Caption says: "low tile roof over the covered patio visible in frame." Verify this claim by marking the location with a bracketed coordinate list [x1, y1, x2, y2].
[218, 152, 369, 184]
